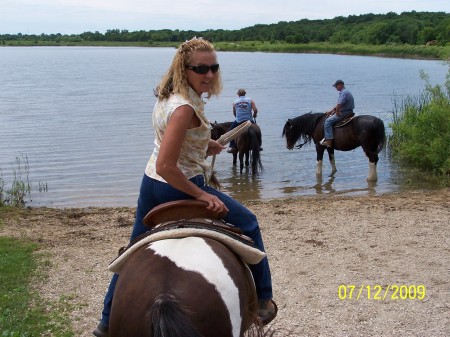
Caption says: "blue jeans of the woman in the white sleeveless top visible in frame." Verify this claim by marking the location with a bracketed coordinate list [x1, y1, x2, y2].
[101, 174, 272, 326]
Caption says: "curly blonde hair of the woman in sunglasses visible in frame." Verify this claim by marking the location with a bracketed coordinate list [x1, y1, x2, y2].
[155, 37, 222, 100]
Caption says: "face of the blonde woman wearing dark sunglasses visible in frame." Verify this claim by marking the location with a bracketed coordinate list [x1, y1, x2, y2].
[186, 51, 217, 96]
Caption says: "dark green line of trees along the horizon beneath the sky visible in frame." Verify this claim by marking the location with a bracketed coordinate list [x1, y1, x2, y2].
[0, 11, 450, 46]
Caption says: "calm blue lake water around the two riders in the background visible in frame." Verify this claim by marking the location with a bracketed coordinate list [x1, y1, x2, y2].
[0, 47, 447, 207]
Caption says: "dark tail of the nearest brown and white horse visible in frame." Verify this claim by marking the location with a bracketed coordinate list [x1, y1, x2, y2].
[150, 294, 201, 337]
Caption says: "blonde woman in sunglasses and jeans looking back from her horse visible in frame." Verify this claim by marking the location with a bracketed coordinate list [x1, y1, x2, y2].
[93, 38, 277, 337]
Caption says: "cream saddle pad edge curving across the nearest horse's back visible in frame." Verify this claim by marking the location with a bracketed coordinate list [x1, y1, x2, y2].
[108, 227, 266, 274]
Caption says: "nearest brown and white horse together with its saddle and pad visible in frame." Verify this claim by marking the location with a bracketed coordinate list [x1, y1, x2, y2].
[109, 200, 265, 337]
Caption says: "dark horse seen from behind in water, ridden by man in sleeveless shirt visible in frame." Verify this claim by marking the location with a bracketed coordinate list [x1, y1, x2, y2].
[211, 122, 264, 176]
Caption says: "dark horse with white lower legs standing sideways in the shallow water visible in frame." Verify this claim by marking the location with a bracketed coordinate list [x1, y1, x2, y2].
[282, 113, 386, 181]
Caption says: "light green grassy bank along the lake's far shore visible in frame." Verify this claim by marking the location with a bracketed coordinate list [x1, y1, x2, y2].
[1, 40, 450, 60]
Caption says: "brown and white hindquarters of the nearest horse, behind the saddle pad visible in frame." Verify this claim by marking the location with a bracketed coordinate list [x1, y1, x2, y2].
[109, 201, 263, 337]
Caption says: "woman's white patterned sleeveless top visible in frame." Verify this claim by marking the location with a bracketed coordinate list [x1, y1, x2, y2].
[145, 88, 211, 182]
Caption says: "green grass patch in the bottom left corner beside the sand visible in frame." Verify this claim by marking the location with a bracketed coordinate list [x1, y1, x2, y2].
[0, 237, 74, 337]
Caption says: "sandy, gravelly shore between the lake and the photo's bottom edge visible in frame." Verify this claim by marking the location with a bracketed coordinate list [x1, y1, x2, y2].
[0, 189, 450, 336]
